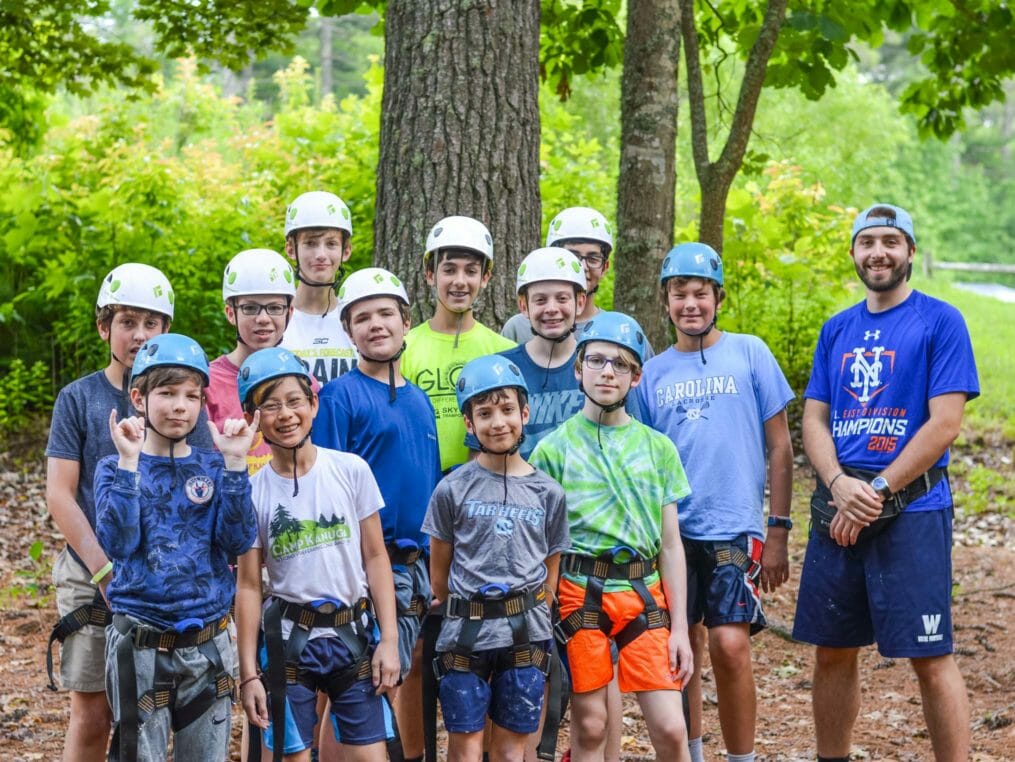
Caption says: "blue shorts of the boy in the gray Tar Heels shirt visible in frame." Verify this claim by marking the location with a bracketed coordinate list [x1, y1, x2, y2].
[438, 641, 550, 734]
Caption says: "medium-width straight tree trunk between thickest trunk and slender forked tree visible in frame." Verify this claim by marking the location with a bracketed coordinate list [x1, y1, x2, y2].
[613, 0, 680, 349]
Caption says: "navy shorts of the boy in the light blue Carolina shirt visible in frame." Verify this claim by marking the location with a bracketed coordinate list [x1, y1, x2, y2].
[681, 535, 767, 635]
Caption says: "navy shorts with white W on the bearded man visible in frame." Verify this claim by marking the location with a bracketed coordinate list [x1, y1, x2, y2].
[793, 509, 952, 659]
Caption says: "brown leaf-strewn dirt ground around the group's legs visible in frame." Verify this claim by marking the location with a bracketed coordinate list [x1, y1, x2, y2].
[0, 458, 1015, 762]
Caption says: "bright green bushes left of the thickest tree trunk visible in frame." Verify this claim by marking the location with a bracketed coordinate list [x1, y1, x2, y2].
[0, 59, 382, 388]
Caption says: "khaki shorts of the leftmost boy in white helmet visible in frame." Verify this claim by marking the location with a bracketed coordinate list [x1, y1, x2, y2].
[53, 548, 106, 693]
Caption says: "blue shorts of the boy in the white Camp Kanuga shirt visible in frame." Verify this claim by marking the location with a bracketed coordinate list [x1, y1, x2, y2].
[261, 637, 395, 754]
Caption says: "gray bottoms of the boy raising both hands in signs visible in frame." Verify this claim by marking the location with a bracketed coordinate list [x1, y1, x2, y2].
[106, 625, 236, 762]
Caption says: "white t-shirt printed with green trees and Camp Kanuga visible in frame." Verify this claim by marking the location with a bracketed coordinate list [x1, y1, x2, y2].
[251, 447, 384, 637]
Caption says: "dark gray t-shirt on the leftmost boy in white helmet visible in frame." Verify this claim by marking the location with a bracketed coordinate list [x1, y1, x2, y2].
[46, 370, 215, 562]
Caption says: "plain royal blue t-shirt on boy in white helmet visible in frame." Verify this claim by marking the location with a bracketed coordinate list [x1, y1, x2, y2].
[311, 367, 441, 547]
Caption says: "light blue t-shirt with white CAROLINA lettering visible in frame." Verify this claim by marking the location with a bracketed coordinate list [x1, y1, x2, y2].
[635, 333, 794, 540]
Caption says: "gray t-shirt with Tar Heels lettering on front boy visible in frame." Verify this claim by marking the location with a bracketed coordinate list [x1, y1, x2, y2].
[423, 461, 570, 651]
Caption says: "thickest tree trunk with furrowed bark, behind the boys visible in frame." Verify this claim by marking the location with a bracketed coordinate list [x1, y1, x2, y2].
[374, 0, 541, 327]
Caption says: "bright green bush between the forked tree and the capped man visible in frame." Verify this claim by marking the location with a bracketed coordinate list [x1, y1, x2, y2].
[676, 162, 855, 393]
